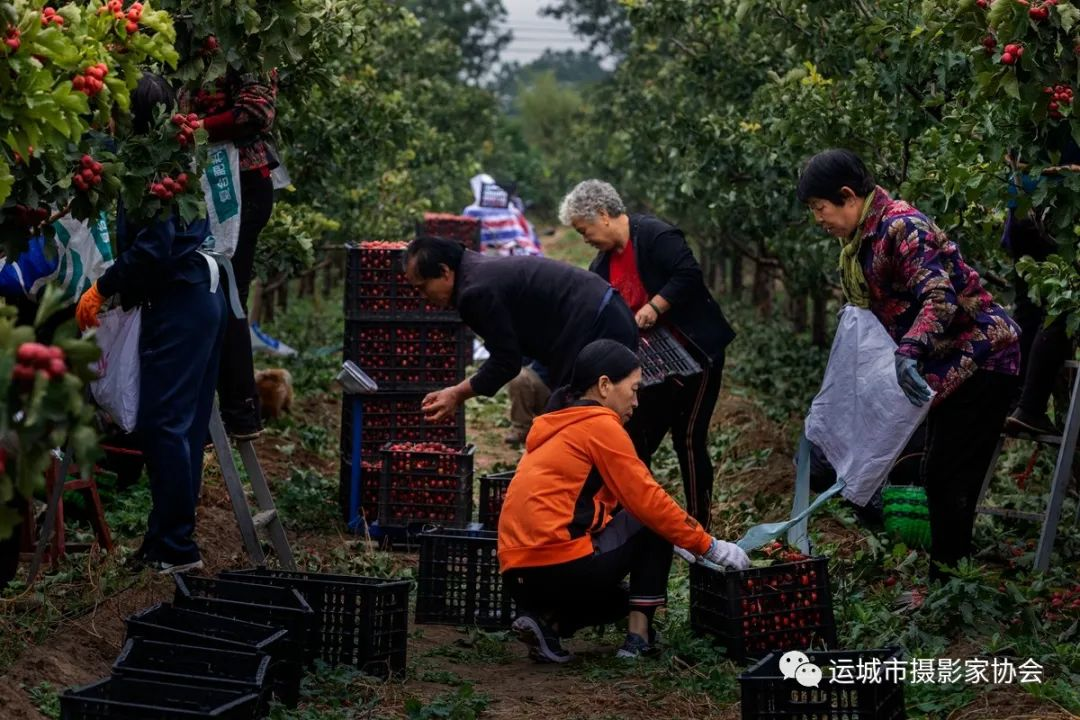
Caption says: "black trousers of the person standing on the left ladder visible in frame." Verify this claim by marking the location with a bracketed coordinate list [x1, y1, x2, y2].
[217, 171, 273, 433]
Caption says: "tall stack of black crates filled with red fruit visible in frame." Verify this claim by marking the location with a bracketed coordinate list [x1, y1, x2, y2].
[339, 241, 472, 541]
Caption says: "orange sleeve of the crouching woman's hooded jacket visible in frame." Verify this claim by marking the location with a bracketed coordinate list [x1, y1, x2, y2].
[588, 417, 713, 555]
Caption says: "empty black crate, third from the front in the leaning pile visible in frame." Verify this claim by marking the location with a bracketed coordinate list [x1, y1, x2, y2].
[124, 602, 303, 707]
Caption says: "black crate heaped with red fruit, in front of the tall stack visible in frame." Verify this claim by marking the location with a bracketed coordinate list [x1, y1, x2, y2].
[380, 443, 472, 522]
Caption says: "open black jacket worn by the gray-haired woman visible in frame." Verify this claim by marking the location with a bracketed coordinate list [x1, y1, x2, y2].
[589, 215, 735, 359]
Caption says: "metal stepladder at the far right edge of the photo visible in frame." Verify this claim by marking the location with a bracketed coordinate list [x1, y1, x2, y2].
[975, 361, 1080, 572]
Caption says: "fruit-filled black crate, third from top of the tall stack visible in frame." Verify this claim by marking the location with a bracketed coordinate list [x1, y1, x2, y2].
[341, 393, 465, 459]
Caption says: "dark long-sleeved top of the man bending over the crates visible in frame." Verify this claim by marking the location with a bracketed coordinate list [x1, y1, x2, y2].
[453, 250, 622, 396]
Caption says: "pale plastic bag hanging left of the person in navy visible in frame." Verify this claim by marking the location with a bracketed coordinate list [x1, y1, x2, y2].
[90, 307, 143, 433]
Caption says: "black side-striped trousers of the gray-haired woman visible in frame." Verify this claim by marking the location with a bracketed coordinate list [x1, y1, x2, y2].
[626, 355, 724, 530]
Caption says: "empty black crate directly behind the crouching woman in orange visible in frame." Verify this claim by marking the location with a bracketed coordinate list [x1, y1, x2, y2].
[416, 529, 514, 628]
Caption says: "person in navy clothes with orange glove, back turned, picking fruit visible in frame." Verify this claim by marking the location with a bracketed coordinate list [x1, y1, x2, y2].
[76, 74, 226, 574]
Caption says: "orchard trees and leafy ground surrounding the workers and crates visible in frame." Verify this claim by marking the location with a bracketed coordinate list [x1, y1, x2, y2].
[0, 0, 1080, 720]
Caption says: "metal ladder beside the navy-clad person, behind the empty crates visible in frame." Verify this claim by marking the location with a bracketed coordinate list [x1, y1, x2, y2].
[210, 399, 296, 570]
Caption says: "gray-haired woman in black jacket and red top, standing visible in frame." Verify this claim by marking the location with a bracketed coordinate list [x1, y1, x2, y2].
[558, 180, 735, 528]
